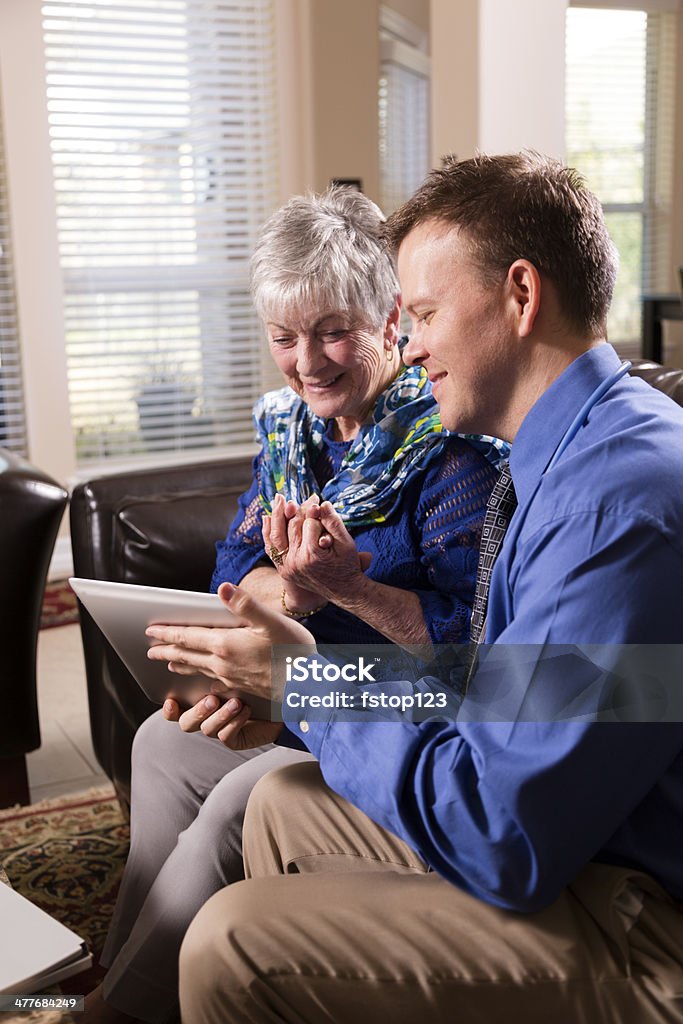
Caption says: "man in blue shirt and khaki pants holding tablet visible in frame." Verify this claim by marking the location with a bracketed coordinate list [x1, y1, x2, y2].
[151, 154, 683, 1024]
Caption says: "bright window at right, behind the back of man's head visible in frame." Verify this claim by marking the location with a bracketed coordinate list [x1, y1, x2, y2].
[566, 0, 676, 354]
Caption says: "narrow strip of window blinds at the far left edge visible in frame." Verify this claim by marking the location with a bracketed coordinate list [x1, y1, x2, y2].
[0, 93, 27, 455]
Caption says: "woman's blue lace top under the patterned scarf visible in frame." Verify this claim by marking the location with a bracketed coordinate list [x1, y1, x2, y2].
[211, 431, 498, 643]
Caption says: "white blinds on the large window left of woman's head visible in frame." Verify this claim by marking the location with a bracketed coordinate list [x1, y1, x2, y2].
[43, 0, 276, 465]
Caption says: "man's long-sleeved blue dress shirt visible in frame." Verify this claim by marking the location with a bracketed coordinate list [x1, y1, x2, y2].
[285, 344, 683, 911]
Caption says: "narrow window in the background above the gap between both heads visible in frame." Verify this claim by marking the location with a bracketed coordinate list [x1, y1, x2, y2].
[379, 7, 429, 216]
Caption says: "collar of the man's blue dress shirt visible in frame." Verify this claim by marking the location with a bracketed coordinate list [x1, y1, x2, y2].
[510, 343, 621, 505]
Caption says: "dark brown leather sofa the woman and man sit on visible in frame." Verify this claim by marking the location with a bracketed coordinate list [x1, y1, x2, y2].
[71, 360, 683, 805]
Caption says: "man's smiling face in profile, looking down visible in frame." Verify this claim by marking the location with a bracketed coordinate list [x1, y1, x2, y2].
[398, 220, 514, 436]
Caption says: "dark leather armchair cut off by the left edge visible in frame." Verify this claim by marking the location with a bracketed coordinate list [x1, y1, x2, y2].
[0, 449, 68, 807]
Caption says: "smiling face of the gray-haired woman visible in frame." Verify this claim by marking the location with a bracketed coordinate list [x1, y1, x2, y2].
[266, 303, 400, 439]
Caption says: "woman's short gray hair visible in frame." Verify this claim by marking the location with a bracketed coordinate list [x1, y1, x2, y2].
[251, 185, 400, 328]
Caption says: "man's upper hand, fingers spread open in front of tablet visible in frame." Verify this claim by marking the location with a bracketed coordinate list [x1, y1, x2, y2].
[145, 583, 315, 700]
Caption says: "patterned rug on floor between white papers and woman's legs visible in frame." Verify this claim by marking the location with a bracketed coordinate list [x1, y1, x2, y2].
[0, 786, 129, 1024]
